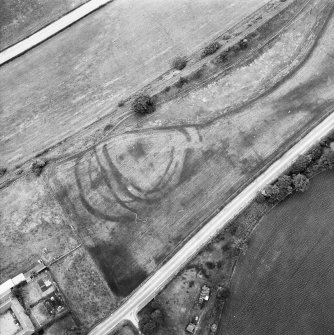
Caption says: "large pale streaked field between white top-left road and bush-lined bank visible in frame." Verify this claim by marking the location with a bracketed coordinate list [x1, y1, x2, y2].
[0, 0, 268, 166]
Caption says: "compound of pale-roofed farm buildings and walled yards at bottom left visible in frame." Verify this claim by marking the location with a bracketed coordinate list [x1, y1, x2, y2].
[0, 263, 69, 335]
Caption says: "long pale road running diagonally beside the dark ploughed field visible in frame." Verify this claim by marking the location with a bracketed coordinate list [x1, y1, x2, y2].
[89, 114, 334, 335]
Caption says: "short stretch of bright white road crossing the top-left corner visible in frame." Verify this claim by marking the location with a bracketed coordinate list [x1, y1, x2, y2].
[0, 0, 112, 65]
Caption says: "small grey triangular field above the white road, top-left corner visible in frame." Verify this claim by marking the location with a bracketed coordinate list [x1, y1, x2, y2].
[0, 0, 87, 51]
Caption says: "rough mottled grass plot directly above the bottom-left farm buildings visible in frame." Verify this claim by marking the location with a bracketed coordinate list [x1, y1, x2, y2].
[0, 176, 78, 282]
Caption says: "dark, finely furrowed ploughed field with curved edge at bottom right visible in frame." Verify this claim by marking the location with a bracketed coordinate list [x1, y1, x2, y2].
[220, 171, 334, 335]
